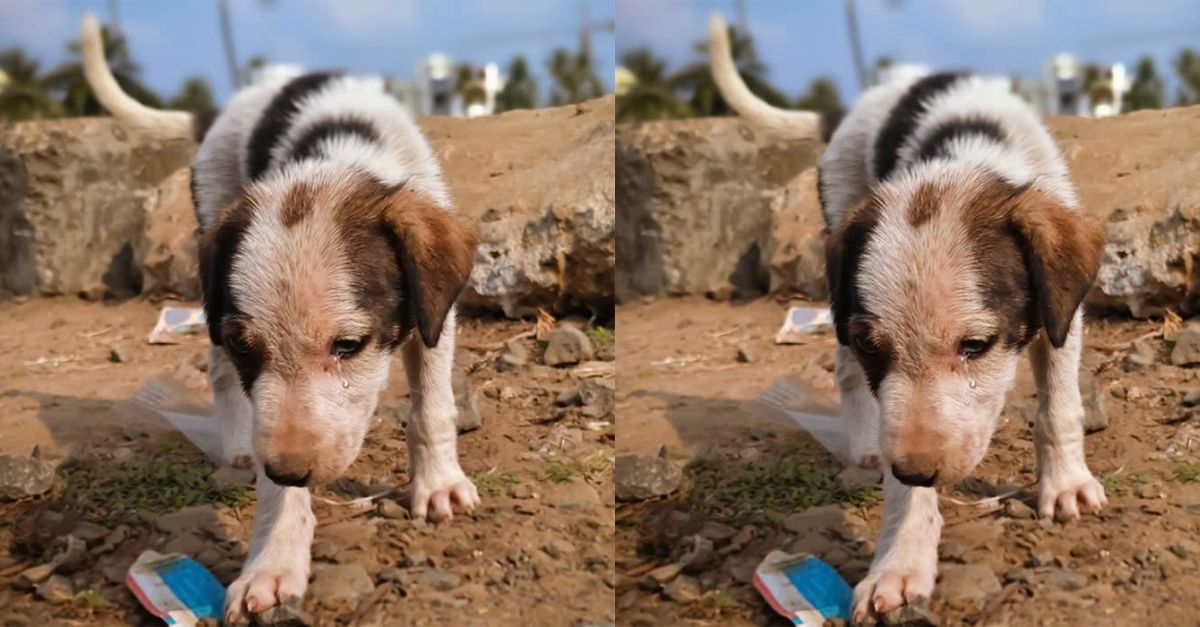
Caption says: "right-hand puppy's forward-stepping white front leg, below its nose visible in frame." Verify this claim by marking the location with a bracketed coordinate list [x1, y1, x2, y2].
[852, 468, 942, 625]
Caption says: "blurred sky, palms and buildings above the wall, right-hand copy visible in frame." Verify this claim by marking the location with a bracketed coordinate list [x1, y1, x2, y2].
[617, 0, 1200, 120]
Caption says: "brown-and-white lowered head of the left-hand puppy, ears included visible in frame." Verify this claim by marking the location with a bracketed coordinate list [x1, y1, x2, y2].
[199, 168, 475, 485]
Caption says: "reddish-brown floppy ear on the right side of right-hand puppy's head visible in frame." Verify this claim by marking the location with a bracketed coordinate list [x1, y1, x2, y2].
[1009, 187, 1104, 348]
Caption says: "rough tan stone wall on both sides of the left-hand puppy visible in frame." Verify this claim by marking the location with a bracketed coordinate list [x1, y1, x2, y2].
[0, 96, 616, 316]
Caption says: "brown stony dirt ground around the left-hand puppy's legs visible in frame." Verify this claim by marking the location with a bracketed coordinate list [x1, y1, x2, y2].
[0, 299, 616, 625]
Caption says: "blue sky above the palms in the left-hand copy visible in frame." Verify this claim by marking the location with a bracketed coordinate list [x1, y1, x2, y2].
[0, 0, 616, 102]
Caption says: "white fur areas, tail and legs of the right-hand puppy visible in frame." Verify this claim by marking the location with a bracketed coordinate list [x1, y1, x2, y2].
[709, 16, 1105, 622]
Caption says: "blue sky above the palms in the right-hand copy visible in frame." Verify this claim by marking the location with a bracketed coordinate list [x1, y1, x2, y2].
[616, 0, 1200, 103]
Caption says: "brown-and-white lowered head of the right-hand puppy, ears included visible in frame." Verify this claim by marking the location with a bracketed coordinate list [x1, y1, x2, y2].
[826, 168, 1104, 485]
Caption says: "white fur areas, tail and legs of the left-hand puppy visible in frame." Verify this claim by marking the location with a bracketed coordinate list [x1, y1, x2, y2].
[83, 16, 479, 622]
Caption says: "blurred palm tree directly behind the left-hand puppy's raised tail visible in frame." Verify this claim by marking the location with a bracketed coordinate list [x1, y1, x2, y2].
[44, 21, 162, 115]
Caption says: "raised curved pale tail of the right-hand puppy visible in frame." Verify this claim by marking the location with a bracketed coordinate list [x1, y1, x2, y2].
[708, 13, 822, 138]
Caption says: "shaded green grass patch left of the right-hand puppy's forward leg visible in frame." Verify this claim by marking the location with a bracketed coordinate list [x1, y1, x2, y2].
[684, 439, 882, 526]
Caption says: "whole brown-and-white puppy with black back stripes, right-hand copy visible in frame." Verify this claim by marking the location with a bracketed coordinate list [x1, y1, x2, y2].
[708, 16, 1106, 622]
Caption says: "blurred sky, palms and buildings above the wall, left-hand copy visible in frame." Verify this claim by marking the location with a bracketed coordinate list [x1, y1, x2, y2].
[0, 0, 616, 120]
